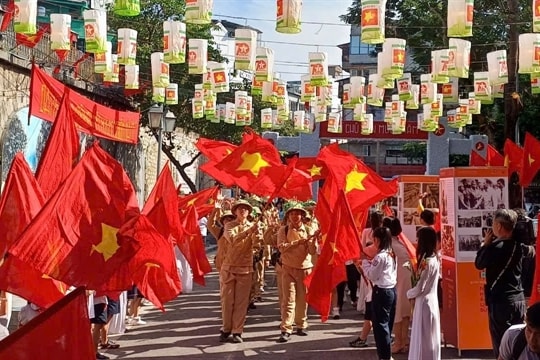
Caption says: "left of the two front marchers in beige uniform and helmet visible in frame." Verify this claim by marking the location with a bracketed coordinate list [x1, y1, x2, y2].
[220, 200, 258, 343]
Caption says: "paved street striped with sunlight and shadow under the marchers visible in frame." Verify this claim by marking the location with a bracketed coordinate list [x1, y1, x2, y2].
[99, 253, 493, 360]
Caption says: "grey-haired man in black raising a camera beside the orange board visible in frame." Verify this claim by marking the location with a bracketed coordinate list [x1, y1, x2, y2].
[475, 209, 535, 357]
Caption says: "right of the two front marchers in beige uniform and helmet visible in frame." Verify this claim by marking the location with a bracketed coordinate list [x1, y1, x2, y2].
[277, 203, 317, 342]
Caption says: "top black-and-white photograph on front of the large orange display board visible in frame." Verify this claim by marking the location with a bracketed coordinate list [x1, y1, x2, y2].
[457, 178, 506, 210]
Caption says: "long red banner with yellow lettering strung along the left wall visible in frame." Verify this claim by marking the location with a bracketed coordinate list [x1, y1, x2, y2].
[29, 66, 140, 144]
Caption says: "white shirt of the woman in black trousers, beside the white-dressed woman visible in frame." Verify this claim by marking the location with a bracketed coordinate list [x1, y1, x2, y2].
[362, 250, 397, 289]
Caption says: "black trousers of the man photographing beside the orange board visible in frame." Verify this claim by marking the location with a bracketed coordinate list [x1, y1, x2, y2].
[487, 300, 527, 358]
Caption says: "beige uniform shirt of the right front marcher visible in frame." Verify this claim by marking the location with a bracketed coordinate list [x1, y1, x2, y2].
[277, 224, 317, 269]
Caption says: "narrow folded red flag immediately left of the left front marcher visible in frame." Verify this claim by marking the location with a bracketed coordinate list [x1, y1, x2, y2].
[176, 206, 212, 286]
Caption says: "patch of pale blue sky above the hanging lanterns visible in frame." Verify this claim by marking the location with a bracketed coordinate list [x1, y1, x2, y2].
[213, 0, 352, 81]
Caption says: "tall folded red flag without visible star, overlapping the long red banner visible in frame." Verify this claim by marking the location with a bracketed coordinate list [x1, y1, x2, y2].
[36, 93, 80, 199]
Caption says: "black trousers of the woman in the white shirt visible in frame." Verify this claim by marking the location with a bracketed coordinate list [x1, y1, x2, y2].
[371, 286, 396, 359]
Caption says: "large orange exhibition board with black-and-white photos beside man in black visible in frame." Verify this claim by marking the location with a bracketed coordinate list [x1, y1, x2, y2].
[439, 167, 508, 351]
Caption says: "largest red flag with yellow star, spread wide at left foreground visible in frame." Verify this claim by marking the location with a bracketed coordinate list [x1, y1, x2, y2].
[9, 143, 139, 290]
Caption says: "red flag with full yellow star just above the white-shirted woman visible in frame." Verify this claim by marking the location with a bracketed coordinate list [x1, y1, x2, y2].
[317, 144, 398, 212]
